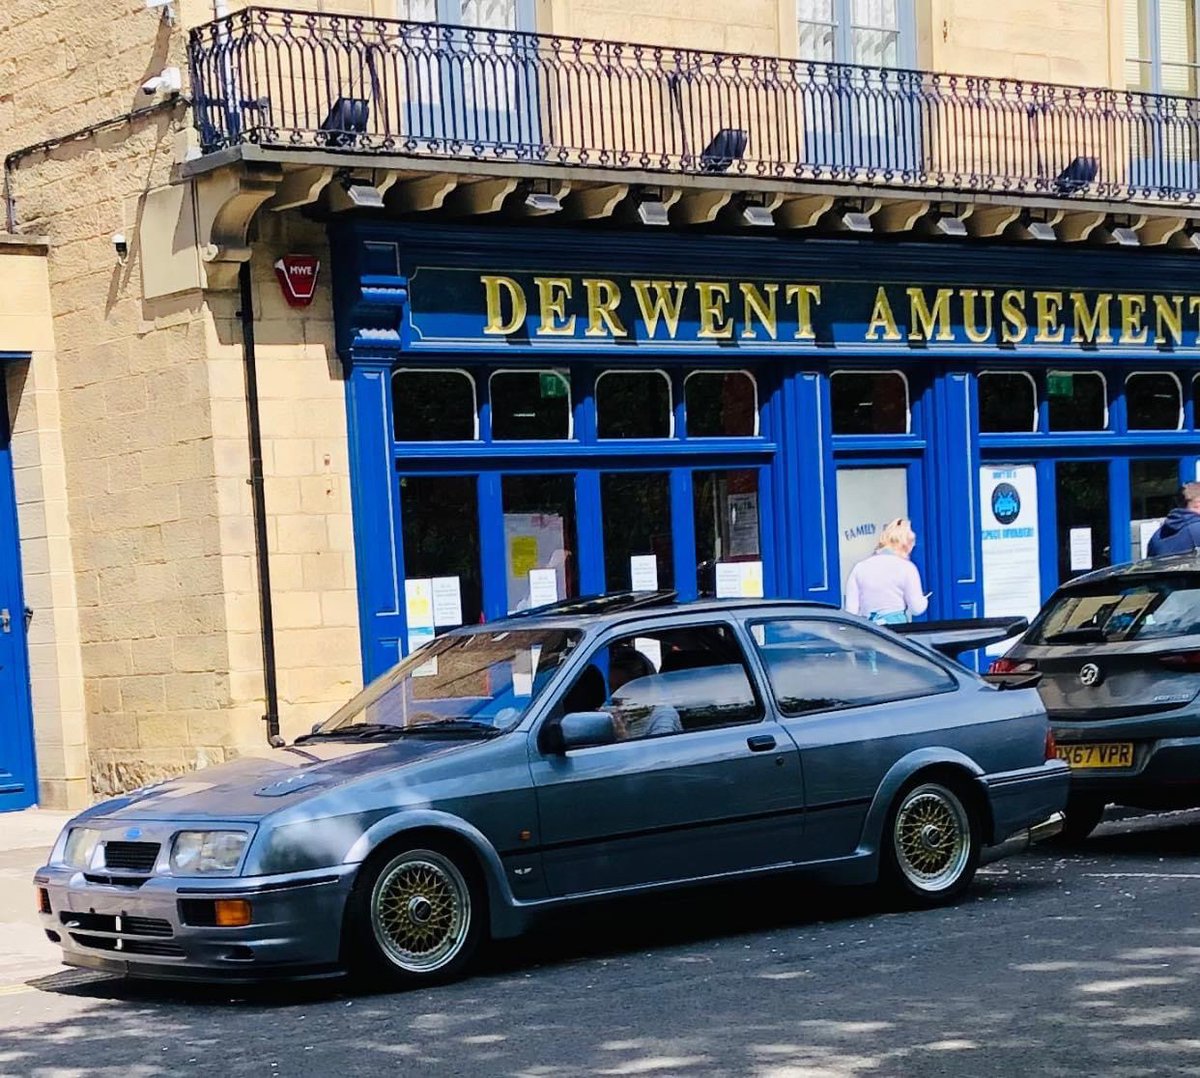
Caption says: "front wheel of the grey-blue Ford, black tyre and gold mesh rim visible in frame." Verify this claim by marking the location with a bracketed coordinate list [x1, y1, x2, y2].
[349, 845, 484, 987]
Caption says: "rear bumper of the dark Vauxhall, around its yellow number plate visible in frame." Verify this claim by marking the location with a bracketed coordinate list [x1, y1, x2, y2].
[1055, 724, 1200, 808]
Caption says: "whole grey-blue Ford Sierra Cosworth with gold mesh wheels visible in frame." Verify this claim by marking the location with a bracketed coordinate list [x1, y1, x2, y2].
[35, 593, 1068, 984]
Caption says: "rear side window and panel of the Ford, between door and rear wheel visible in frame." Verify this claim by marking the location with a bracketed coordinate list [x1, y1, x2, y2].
[750, 616, 973, 861]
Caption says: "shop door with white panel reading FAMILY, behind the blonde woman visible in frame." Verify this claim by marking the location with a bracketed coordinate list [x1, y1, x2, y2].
[838, 463, 936, 603]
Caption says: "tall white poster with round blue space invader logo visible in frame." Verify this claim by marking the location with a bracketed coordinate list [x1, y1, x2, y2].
[979, 465, 1042, 654]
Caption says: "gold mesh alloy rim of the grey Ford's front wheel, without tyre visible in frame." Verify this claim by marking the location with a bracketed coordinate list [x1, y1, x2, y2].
[371, 850, 470, 974]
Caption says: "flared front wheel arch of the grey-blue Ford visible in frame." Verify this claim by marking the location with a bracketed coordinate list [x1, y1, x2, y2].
[346, 809, 524, 939]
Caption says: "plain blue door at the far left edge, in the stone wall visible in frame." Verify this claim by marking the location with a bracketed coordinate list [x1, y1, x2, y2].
[0, 366, 37, 812]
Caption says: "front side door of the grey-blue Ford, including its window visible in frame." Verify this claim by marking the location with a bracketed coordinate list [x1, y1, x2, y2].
[530, 619, 804, 896]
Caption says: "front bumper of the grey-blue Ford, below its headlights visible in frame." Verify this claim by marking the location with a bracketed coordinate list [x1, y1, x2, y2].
[34, 864, 358, 981]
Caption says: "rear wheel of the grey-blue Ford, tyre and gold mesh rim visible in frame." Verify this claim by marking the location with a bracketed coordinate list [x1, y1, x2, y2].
[883, 781, 980, 908]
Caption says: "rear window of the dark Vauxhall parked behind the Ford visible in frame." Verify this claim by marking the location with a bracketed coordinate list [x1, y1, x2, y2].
[1024, 576, 1200, 646]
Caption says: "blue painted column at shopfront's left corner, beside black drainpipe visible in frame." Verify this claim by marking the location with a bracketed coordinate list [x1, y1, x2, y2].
[346, 353, 404, 682]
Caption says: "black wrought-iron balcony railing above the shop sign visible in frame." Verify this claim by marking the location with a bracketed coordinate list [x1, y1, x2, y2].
[190, 8, 1200, 203]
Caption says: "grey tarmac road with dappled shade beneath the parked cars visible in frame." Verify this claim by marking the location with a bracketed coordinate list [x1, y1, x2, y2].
[0, 812, 1200, 1078]
